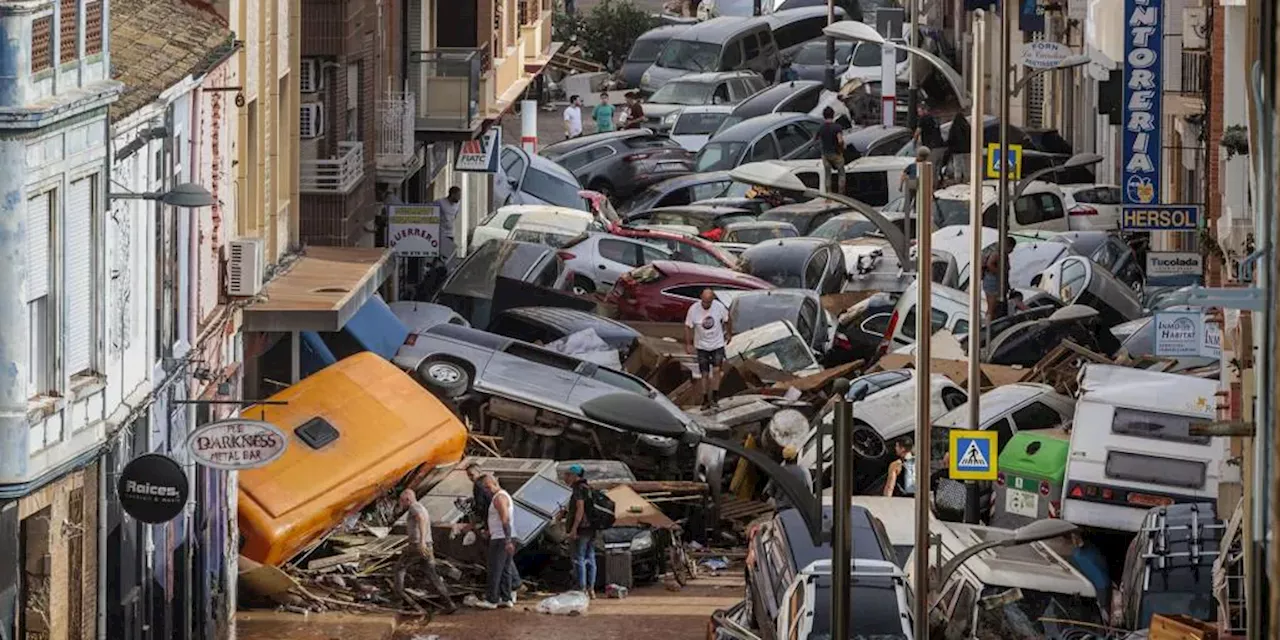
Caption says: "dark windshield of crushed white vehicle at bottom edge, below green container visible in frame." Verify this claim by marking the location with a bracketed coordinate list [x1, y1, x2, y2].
[977, 586, 1102, 639]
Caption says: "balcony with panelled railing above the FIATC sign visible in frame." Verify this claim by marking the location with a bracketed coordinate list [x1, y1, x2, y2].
[410, 49, 484, 132]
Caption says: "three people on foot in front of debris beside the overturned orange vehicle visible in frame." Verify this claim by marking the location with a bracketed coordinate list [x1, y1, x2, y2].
[394, 465, 596, 613]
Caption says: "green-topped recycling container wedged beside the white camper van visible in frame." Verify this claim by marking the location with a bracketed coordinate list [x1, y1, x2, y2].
[992, 429, 1071, 529]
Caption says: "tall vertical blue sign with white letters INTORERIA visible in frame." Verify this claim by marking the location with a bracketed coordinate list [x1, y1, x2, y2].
[1121, 0, 1165, 205]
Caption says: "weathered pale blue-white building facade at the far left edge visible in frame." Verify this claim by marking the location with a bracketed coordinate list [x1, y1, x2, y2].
[0, 0, 120, 639]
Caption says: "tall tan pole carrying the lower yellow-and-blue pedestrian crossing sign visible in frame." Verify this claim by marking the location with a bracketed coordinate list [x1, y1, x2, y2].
[962, 10, 987, 527]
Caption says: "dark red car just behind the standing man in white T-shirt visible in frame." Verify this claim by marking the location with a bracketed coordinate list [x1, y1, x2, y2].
[604, 260, 773, 323]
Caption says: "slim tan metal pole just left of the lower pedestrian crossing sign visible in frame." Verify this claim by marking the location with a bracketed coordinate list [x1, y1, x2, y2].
[914, 163, 933, 640]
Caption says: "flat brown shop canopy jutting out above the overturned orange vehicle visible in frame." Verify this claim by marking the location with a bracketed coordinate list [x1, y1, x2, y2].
[244, 247, 396, 332]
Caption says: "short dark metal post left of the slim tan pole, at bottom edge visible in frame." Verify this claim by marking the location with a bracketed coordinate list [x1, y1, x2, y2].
[831, 380, 854, 637]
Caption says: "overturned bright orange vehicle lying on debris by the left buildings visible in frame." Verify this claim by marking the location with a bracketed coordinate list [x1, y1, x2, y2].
[238, 352, 467, 566]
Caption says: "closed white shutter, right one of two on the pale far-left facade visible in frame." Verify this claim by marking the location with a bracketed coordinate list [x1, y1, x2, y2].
[63, 177, 95, 375]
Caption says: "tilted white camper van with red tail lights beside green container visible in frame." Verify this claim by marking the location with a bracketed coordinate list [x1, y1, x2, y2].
[1062, 365, 1223, 531]
